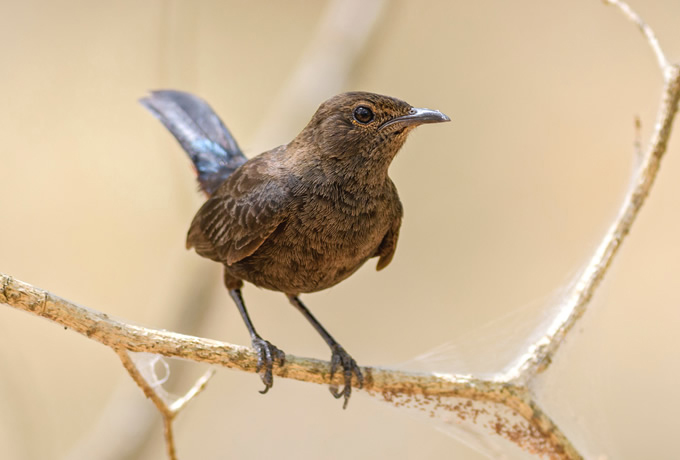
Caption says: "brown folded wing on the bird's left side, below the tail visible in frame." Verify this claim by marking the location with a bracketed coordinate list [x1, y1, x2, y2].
[187, 154, 290, 265]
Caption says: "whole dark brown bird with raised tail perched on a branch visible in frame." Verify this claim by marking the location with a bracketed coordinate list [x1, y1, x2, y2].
[140, 90, 450, 408]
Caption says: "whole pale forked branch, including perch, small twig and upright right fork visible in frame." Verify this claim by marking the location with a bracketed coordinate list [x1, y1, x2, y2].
[0, 0, 680, 459]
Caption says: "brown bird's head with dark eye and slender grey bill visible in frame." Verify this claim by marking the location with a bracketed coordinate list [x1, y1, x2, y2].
[296, 92, 450, 172]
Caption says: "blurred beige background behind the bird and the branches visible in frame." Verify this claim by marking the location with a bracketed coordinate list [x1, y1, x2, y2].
[0, 0, 680, 460]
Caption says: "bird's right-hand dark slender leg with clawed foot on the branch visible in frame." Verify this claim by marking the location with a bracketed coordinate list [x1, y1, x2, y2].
[286, 294, 364, 409]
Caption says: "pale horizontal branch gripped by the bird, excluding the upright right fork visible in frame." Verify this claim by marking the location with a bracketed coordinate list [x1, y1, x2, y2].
[0, 273, 581, 459]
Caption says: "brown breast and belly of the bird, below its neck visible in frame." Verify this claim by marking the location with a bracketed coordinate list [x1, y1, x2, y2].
[230, 187, 398, 294]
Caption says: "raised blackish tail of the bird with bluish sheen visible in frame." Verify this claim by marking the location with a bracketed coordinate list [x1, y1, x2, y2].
[139, 90, 247, 196]
